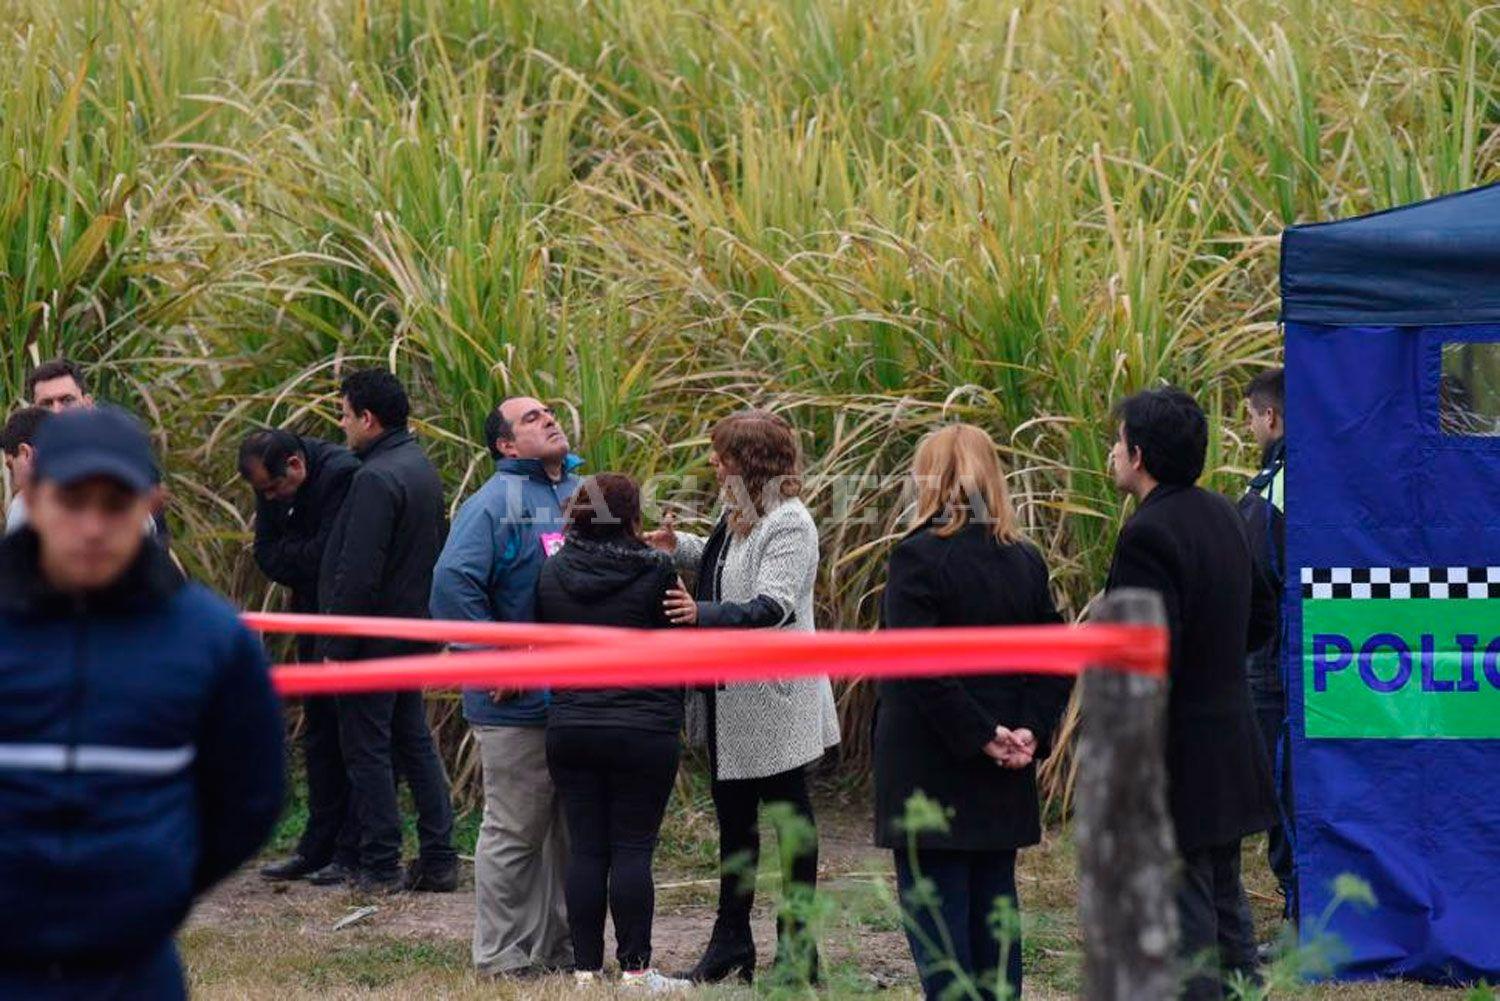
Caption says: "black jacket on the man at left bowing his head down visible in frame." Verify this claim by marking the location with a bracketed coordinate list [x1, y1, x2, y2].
[255, 438, 360, 614]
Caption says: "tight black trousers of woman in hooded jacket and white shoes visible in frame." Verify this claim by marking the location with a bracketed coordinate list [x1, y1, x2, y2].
[548, 726, 681, 971]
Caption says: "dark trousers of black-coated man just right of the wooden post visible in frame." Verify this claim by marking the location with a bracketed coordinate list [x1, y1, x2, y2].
[1178, 840, 1256, 1001]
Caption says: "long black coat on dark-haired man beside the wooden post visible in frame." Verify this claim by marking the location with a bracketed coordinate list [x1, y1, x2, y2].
[1109, 485, 1277, 849]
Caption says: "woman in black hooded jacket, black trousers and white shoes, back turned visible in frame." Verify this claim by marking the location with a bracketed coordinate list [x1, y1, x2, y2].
[537, 473, 683, 990]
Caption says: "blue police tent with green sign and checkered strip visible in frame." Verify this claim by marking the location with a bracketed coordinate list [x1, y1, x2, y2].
[1281, 185, 1500, 981]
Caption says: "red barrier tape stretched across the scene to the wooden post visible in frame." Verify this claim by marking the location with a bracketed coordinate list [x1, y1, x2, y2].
[245, 614, 1167, 695]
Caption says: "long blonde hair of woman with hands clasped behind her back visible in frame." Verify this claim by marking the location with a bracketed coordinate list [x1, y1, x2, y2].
[912, 425, 1022, 543]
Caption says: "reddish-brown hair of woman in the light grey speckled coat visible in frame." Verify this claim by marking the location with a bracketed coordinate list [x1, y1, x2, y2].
[708, 410, 803, 536]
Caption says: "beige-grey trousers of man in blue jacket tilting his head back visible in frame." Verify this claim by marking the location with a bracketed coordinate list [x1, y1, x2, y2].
[474, 726, 573, 974]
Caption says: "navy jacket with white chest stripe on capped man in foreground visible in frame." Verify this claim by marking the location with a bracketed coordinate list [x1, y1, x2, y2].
[0, 530, 284, 978]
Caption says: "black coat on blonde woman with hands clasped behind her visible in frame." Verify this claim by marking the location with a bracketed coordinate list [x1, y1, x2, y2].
[875, 524, 1073, 851]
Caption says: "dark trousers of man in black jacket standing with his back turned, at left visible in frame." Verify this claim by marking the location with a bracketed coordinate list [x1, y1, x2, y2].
[338, 692, 458, 876]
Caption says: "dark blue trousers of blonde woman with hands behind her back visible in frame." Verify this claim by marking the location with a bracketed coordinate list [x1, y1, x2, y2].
[894, 849, 1022, 1001]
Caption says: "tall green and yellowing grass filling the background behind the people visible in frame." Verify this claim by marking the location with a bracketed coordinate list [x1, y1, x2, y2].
[0, 0, 1500, 798]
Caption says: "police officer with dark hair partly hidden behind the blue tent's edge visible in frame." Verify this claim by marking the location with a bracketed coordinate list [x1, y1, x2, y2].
[1239, 368, 1296, 920]
